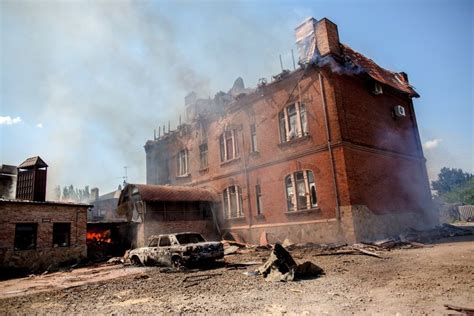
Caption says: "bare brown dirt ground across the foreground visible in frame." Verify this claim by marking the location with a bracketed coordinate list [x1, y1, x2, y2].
[0, 236, 474, 315]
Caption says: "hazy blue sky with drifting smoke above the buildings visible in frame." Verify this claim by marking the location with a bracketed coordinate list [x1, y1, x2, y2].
[0, 0, 474, 197]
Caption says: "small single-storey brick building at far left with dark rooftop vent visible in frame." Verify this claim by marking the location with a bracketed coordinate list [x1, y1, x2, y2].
[0, 157, 90, 272]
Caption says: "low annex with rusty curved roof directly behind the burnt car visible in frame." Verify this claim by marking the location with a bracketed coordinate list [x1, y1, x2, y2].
[118, 184, 219, 247]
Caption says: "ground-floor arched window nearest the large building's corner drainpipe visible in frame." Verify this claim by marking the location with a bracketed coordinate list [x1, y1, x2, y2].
[285, 170, 318, 212]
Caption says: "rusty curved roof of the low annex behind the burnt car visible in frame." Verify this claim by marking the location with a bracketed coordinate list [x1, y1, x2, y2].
[124, 184, 219, 202]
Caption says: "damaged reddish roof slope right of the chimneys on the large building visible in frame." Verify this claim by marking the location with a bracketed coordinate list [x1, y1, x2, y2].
[341, 44, 420, 98]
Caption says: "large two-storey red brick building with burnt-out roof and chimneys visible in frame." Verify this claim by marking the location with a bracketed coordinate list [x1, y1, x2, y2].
[145, 19, 431, 242]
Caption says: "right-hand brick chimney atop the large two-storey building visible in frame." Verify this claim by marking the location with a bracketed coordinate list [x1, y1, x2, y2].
[315, 18, 341, 56]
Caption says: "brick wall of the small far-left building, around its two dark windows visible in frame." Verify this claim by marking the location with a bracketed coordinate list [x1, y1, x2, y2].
[0, 201, 87, 270]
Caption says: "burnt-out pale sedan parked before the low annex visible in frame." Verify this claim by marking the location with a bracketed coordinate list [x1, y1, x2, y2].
[129, 232, 224, 267]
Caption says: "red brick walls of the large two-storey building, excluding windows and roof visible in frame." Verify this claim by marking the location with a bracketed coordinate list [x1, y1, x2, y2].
[147, 69, 429, 242]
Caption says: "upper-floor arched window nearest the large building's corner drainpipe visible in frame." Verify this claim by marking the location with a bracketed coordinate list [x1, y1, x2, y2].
[278, 102, 308, 143]
